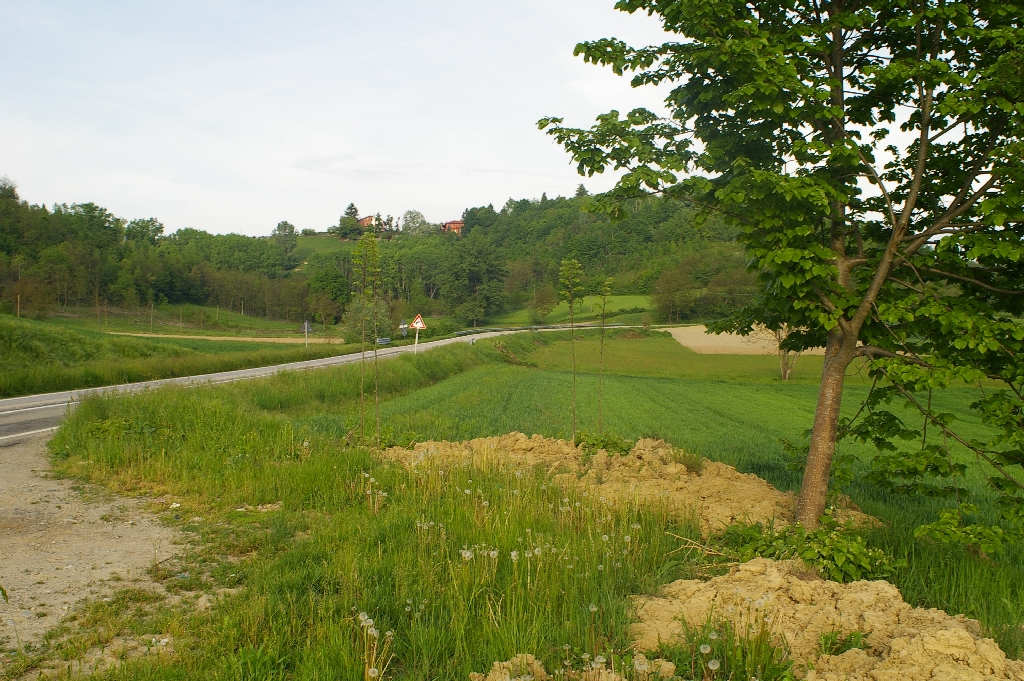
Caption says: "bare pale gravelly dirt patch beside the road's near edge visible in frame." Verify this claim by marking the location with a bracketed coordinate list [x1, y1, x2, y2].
[0, 433, 175, 647]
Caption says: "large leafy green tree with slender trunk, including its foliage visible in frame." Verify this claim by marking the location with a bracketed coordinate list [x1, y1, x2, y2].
[541, 0, 1024, 526]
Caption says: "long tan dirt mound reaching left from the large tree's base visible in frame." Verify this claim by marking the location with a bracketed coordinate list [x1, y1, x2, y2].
[385, 433, 795, 534]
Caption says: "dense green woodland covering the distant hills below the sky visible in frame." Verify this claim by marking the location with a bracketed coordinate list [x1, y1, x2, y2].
[0, 179, 755, 324]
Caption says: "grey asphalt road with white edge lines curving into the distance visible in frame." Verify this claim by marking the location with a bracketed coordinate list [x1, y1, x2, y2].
[0, 331, 520, 442]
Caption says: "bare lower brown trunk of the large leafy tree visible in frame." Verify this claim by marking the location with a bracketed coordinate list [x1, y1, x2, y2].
[797, 327, 857, 528]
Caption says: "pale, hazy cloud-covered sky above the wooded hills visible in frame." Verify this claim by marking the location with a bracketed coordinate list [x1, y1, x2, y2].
[0, 0, 667, 235]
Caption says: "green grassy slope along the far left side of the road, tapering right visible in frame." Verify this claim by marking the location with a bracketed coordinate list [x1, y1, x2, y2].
[0, 315, 354, 397]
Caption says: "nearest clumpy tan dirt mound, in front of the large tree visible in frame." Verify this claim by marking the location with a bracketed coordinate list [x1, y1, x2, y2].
[634, 558, 1024, 681]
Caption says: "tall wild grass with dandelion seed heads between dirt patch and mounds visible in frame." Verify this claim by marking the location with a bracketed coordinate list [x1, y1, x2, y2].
[51, 347, 698, 680]
